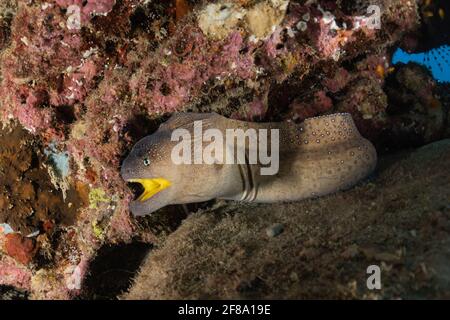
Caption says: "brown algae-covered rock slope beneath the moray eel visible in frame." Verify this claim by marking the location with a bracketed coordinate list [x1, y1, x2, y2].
[122, 139, 450, 299]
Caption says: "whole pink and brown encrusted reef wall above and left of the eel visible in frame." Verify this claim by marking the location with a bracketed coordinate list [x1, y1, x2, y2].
[0, 0, 448, 298]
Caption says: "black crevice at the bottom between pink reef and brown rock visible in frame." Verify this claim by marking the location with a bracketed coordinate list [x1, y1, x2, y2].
[80, 242, 152, 299]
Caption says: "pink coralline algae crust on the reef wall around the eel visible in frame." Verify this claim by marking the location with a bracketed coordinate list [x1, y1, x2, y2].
[0, 0, 442, 298]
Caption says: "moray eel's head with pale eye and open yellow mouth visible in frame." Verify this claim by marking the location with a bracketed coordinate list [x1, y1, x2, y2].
[120, 132, 176, 216]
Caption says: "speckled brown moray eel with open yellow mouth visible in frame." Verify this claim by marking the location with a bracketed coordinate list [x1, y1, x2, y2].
[121, 113, 377, 216]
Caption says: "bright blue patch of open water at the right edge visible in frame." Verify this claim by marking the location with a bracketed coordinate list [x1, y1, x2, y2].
[392, 45, 450, 82]
